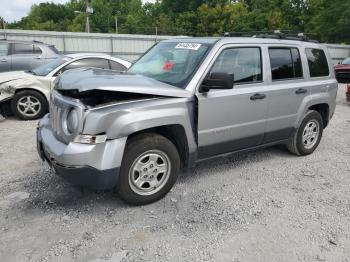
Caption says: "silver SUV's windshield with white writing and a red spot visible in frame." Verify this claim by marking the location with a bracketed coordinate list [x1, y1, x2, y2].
[128, 42, 211, 88]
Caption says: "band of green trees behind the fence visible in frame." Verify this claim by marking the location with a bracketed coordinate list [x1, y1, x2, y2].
[4, 0, 350, 43]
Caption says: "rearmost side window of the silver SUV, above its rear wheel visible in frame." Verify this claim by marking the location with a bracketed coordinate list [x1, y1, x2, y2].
[305, 48, 329, 77]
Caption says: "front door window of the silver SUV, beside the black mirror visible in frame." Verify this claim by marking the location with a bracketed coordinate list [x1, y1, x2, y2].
[211, 47, 262, 84]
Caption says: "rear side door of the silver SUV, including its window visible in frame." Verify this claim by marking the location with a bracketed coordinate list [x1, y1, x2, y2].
[263, 46, 310, 143]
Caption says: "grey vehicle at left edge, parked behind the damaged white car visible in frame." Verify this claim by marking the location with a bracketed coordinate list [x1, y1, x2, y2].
[0, 40, 60, 73]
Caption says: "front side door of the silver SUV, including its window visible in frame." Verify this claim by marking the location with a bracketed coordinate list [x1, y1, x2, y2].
[197, 46, 268, 159]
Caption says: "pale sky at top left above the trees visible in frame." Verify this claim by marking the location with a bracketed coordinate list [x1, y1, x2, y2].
[0, 0, 152, 22]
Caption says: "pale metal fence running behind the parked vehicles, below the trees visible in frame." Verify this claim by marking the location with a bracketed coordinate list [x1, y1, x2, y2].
[0, 30, 350, 64]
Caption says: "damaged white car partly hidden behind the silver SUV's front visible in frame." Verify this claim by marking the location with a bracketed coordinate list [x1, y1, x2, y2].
[0, 53, 131, 120]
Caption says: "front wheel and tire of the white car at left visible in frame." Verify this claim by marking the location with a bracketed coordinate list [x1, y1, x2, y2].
[11, 90, 48, 120]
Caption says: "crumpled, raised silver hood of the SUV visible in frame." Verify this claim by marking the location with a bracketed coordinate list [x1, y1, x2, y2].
[55, 68, 192, 97]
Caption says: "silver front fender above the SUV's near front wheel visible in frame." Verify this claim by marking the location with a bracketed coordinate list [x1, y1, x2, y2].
[83, 98, 196, 152]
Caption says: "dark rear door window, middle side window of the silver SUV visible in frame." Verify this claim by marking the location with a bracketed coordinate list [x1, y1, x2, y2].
[269, 48, 303, 80]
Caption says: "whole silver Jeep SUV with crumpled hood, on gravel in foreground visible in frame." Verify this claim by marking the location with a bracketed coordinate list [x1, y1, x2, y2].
[37, 37, 338, 205]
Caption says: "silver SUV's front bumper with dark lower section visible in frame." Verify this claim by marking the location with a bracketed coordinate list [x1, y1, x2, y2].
[37, 115, 126, 190]
